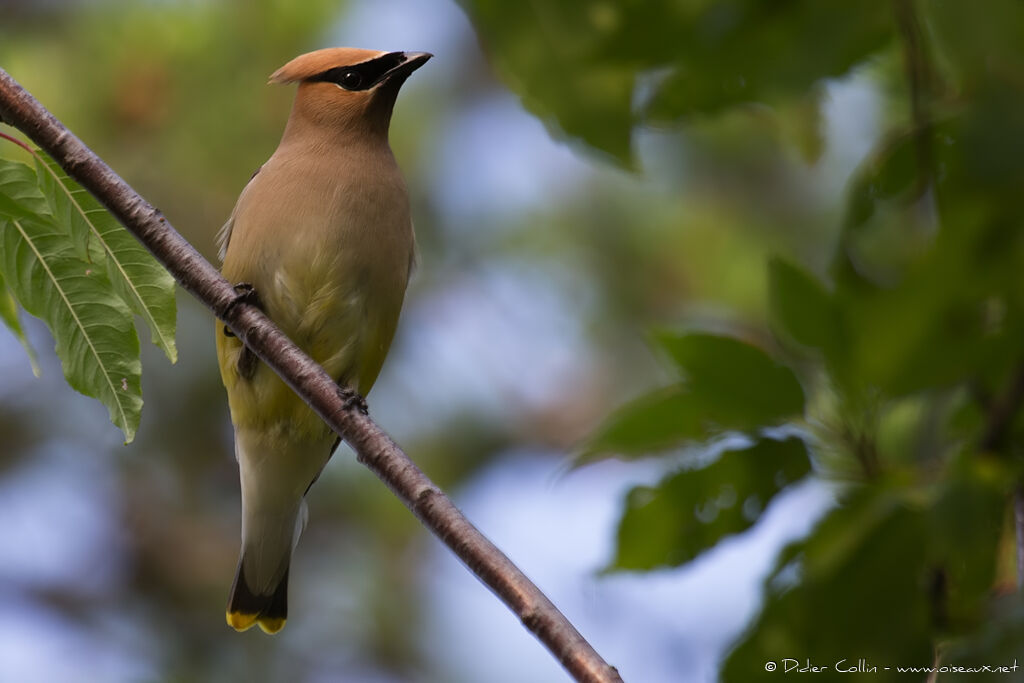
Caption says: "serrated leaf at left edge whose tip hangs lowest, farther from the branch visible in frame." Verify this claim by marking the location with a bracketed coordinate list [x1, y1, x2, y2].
[0, 219, 142, 442]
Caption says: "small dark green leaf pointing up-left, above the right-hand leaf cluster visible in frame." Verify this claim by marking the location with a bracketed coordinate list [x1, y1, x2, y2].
[768, 258, 841, 352]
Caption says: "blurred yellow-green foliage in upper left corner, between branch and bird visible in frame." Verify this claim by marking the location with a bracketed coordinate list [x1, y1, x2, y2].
[0, 0, 340, 257]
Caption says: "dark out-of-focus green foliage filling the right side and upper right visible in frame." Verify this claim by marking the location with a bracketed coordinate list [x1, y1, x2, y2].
[463, 0, 1024, 681]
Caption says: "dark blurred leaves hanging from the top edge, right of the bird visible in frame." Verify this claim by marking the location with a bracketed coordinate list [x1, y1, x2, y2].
[461, 0, 891, 164]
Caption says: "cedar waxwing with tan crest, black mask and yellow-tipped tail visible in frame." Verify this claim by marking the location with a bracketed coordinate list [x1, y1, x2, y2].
[217, 47, 431, 633]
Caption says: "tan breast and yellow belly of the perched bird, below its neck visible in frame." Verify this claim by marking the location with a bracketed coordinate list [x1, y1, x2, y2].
[218, 154, 414, 438]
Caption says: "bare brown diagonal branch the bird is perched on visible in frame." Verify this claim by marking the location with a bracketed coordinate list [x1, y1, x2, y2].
[0, 69, 622, 683]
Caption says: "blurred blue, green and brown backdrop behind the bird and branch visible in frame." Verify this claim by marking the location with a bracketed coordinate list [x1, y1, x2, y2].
[0, 0, 1019, 683]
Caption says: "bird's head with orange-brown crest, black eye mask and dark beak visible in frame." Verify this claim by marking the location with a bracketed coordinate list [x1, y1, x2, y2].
[270, 47, 432, 137]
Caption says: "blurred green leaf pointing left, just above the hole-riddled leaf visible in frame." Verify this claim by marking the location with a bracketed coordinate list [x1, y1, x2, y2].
[580, 385, 707, 462]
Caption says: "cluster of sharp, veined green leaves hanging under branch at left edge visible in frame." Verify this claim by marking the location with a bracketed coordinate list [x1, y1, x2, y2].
[0, 143, 177, 441]
